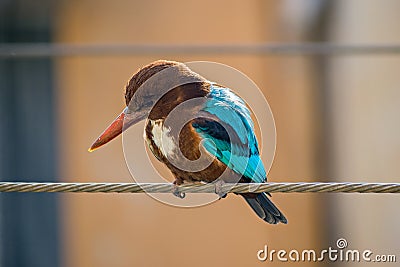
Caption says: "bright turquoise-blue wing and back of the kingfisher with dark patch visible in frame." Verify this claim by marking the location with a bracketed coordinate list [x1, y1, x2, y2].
[192, 84, 266, 183]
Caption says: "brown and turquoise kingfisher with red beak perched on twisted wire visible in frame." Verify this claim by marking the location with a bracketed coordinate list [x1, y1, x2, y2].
[89, 60, 287, 224]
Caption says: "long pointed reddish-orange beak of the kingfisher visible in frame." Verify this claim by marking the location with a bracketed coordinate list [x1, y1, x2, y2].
[88, 108, 144, 152]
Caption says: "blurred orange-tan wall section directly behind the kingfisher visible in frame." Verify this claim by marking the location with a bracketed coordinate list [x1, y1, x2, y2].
[57, 0, 323, 267]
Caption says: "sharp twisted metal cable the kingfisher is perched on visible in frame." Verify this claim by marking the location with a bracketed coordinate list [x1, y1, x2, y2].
[0, 182, 400, 194]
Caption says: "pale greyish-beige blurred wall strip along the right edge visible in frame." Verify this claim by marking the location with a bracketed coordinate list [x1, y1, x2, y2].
[328, 0, 400, 266]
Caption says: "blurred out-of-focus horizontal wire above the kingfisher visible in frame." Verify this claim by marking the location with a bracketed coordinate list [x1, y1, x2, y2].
[0, 43, 400, 58]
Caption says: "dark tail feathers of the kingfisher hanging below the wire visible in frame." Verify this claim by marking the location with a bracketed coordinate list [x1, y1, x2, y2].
[241, 193, 287, 224]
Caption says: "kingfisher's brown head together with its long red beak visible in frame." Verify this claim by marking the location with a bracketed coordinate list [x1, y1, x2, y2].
[89, 60, 205, 152]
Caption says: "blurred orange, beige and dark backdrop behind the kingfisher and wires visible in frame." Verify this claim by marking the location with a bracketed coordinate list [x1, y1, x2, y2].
[0, 0, 400, 267]
